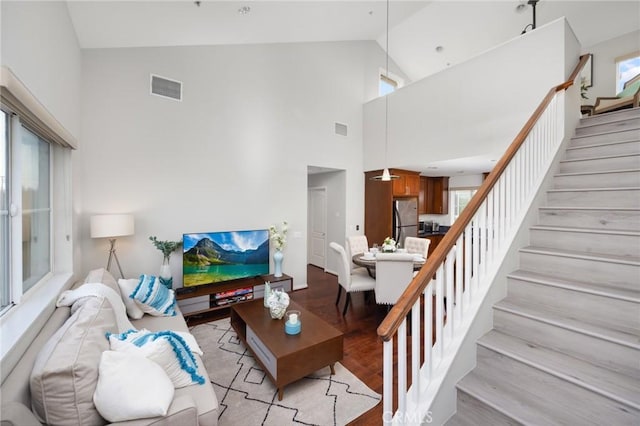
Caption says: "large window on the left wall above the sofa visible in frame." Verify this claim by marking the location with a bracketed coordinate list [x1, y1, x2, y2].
[0, 111, 52, 308]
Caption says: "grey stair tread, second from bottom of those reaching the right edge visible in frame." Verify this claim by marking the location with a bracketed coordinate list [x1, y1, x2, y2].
[494, 296, 640, 350]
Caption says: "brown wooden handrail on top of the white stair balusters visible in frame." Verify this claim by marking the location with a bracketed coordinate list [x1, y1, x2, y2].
[377, 54, 589, 341]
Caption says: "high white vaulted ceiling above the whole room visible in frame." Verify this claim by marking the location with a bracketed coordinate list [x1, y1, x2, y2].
[67, 0, 640, 80]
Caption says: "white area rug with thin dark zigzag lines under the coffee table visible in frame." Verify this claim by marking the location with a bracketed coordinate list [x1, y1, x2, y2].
[191, 319, 380, 426]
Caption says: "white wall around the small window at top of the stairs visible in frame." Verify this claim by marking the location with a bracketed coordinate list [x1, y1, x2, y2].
[582, 30, 640, 100]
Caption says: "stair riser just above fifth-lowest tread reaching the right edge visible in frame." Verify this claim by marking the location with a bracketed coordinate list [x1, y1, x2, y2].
[538, 208, 640, 231]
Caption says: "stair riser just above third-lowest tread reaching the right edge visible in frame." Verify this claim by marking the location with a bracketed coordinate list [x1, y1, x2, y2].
[520, 251, 640, 290]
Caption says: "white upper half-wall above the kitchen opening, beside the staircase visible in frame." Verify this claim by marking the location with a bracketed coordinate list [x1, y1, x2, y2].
[363, 19, 578, 175]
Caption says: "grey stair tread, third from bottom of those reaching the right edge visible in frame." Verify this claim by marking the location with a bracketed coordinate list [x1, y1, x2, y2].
[507, 269, 640, 303]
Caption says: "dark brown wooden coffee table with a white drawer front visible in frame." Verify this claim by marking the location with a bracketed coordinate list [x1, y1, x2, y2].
[231, 299, 343, 401]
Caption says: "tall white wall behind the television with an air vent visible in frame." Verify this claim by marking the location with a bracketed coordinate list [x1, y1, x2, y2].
[76, 42, 384, 286]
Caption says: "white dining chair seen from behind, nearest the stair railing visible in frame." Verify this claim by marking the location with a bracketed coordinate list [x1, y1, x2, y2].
[375, 253, 414, 305]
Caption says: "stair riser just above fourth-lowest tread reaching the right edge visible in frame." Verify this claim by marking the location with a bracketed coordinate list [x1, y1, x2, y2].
[530, 225, 640, 258]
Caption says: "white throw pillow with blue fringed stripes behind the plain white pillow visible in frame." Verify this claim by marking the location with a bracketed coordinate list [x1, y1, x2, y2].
[107, 330, 204, 389]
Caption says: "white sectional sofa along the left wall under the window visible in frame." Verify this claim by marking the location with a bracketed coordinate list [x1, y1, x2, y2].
[0, 269, 218, 426]
